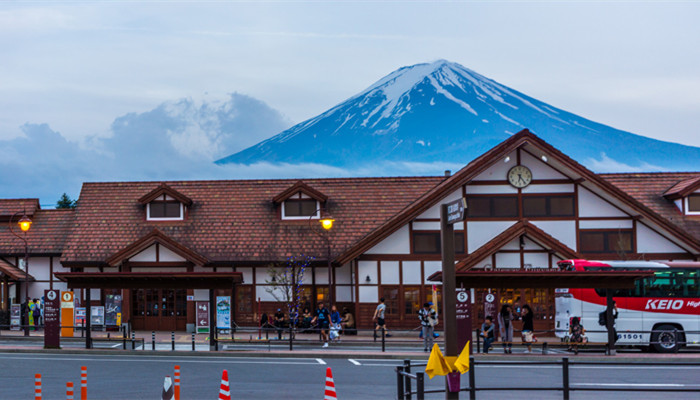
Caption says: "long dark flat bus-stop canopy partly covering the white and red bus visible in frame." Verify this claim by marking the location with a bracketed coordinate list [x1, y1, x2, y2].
[428, 268, 654, 289]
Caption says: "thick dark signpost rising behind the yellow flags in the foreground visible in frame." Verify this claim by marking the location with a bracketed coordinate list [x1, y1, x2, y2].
[440, 204, 459, 400]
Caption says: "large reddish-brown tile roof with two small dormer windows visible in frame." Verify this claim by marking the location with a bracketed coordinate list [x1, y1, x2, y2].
[62, 177, 444, 263]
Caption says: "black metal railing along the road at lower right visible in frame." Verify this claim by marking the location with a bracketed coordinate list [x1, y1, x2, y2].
[395, 357, 700, 400]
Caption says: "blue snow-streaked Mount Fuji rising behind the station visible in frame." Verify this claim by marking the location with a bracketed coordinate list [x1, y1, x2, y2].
[216, 60, 700, 172]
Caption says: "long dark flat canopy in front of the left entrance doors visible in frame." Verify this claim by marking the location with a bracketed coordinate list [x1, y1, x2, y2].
[54, 272, 243, 289]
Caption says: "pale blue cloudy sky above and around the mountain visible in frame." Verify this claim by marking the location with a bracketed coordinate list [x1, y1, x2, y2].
[0, 1, 700, 203]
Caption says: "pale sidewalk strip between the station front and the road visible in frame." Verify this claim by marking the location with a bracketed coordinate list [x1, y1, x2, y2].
[0, 330, 700, 362]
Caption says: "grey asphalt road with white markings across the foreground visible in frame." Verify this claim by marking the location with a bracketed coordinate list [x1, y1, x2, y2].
[0, 353, 700, 400]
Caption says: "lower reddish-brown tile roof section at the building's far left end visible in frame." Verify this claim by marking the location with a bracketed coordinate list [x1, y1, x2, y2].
[0, 208, 74, 256]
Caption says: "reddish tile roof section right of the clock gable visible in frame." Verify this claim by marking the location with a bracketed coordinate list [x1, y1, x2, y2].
[599, 172, 700, 240]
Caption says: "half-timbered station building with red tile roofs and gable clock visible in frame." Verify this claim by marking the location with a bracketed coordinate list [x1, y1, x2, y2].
[0, 130, 700, 330]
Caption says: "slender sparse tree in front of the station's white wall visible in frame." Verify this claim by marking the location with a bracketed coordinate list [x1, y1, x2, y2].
[265, 254, 314, 327]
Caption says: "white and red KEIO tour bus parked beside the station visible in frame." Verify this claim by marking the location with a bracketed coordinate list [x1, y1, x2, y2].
[554, 260, 700, 353]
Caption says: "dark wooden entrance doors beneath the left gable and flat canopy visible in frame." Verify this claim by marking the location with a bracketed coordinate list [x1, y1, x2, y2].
[131, 289, 187, 331]
